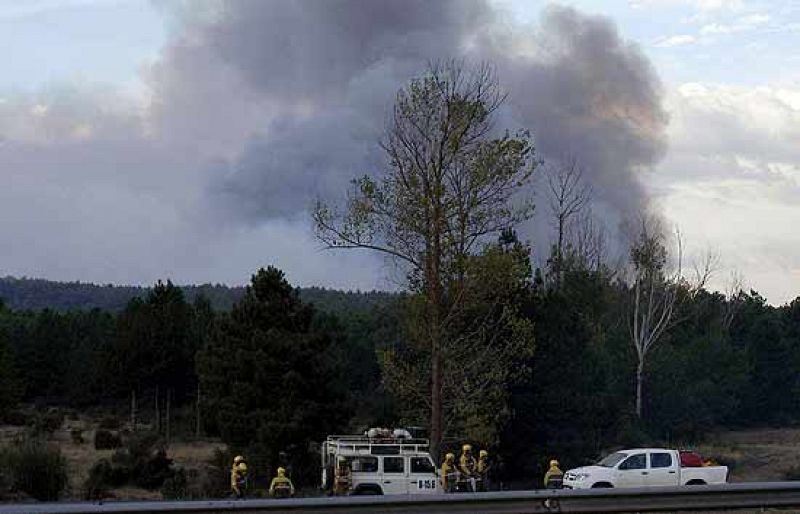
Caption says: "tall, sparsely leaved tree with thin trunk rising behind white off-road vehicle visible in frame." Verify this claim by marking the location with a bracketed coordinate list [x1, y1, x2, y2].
[314, 62, 534, 452]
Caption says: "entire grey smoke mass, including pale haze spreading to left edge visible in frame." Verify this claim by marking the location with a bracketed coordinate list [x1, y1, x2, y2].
[0, 0, 667, 288]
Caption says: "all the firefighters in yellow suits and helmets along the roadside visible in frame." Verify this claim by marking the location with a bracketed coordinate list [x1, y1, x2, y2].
[231, 444, 564, 498]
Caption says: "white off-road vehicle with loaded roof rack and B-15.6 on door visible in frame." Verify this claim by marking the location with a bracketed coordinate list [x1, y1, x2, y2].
[321, 429, 442, 494]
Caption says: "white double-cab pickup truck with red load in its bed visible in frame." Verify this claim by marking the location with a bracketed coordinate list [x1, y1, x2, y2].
[564, 448, 728, 489]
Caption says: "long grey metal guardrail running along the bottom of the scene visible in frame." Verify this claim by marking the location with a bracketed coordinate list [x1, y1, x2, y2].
[0, 482, 800, 514]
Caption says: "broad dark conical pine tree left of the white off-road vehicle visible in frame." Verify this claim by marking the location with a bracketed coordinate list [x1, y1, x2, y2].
[197, 267, 348, 482]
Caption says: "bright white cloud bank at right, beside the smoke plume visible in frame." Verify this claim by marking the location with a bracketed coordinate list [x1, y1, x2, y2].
[652, 83, 800, 303]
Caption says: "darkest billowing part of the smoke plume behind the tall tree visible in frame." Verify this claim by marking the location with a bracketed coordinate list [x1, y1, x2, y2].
[165, 0, 667, 239]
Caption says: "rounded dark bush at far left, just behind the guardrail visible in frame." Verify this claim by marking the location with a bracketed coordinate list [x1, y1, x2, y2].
[0, 439, 67, 501]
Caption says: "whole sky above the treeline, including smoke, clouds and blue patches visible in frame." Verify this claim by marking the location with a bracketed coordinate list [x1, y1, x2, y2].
[0, 0, 800, 304]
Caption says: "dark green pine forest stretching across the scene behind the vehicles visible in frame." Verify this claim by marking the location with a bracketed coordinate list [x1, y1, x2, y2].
[0, 260, 800, 484]
